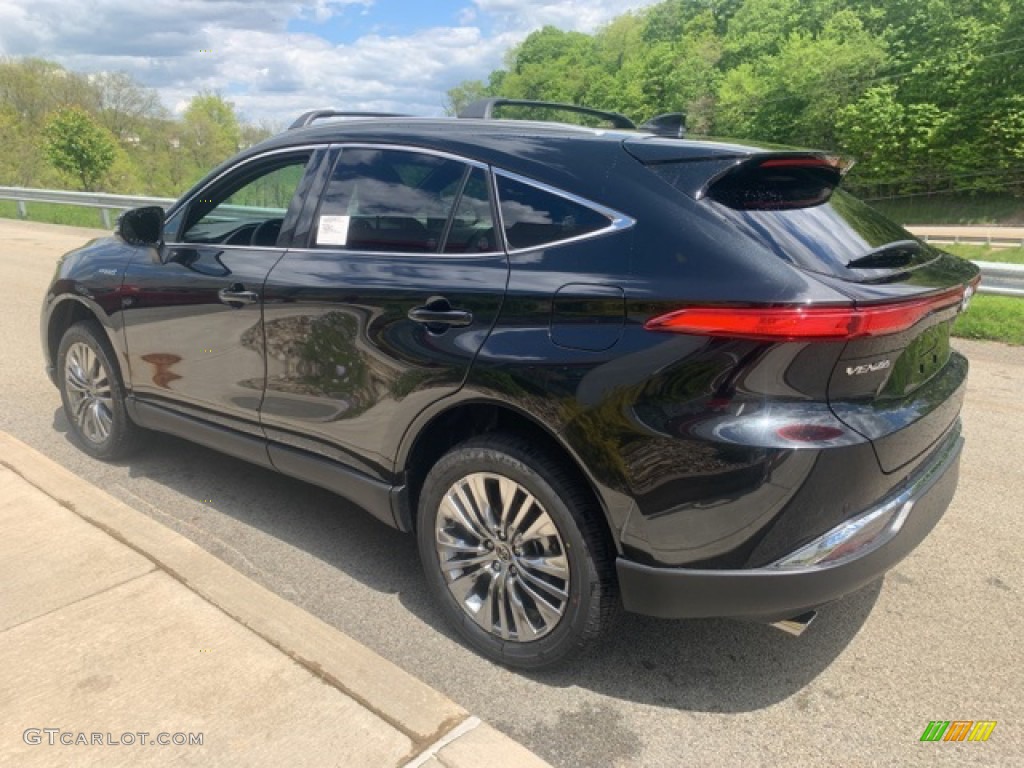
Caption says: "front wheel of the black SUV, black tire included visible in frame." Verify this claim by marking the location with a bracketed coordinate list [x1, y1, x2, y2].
[56, 321, 140, 461]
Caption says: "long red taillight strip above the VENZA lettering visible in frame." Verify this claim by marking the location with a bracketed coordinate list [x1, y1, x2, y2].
[644, 287, 965, 341]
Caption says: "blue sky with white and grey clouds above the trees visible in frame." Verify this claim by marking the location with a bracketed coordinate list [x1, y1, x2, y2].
[0, 0, 656, 127]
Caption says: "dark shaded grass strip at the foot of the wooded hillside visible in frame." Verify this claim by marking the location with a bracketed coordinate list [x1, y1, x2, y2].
[868, 195, 1024, 226]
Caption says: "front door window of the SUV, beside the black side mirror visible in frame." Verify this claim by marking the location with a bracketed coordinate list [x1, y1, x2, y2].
[181, 155, 309, 247]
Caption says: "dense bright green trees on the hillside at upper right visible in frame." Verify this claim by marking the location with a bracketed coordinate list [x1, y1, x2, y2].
[447, 0, 1024, 205]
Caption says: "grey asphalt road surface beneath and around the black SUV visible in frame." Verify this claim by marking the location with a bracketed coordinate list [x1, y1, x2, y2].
[0, 220, 1024, 768]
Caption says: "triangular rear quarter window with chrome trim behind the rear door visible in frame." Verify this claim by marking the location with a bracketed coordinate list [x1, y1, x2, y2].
[498, 175, 611, 250]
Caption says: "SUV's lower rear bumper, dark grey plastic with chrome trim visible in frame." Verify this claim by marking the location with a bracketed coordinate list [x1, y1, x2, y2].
[615, 428, 964, 622]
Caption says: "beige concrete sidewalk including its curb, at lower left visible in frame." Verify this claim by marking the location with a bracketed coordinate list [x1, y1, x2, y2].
[0, 432, 547, 768]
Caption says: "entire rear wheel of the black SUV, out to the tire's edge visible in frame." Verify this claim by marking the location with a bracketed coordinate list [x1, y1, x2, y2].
[417, 434, 618, 670]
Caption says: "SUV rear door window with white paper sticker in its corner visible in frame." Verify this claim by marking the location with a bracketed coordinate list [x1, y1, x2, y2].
[315, 148, 467, 253]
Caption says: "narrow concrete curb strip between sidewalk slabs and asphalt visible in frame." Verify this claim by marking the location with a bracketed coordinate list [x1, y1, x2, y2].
[0, 431, 548, 768]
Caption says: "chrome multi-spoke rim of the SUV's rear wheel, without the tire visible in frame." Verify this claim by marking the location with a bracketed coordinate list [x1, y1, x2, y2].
[434, 472, 569, 642]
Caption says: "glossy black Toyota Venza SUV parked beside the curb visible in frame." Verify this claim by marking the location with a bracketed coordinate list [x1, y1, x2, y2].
[42, 101, 978, 668]
